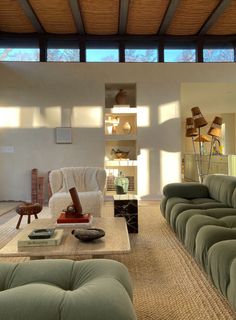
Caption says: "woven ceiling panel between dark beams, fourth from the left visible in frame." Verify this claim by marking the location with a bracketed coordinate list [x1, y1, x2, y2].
[127, 0, 169, 34]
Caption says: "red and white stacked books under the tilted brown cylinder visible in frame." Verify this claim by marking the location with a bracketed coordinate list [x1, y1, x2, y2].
[57, 212, 93, 227]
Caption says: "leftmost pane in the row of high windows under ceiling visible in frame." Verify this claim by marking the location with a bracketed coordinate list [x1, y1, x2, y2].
[0, 48, 39, 61]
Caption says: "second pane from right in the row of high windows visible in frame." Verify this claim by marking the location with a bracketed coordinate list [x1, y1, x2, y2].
[164, 49, 196, 62]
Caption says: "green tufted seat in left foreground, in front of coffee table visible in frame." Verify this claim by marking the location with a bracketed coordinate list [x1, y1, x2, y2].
[0, 259, 136, 320]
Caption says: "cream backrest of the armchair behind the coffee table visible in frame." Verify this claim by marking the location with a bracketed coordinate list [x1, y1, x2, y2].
[49, 167, 106, 193]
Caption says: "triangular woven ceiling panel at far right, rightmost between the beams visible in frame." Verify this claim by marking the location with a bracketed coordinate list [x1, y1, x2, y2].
[207, 0, 236, 35]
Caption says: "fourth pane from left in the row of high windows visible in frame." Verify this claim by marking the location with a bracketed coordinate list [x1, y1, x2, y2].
[125, 49, 158, 62]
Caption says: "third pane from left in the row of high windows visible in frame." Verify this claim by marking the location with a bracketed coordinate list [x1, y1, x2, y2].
[86, 49, 119, 62]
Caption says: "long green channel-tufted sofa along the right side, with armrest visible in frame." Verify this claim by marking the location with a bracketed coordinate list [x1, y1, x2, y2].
[160, 175, 236, 310]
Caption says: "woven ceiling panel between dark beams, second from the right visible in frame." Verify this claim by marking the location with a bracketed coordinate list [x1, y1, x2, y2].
[166, 0, 219, 35]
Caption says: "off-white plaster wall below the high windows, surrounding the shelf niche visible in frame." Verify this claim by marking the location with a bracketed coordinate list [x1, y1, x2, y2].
[0, 63, 236, 200]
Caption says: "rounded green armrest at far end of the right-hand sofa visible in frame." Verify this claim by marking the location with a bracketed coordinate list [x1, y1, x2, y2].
[163, 182, 209, 199]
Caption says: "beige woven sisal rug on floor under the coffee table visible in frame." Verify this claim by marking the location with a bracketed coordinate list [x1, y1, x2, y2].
[0, 205, 236, 320]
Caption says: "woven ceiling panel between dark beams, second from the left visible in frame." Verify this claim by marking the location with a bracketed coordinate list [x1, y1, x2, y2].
[30, 0, 76, 34]
